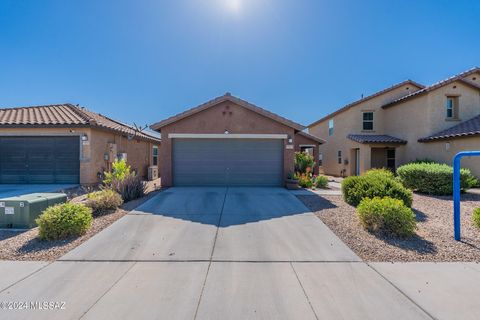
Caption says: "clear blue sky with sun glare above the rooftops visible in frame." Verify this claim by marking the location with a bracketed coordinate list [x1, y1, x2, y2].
[0, 0, 480, 125]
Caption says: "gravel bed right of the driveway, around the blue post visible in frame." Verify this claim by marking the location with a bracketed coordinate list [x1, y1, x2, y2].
[298, 193, 480, 262]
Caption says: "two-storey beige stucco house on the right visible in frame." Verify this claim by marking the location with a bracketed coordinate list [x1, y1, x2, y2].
[308, 68, 480, 176]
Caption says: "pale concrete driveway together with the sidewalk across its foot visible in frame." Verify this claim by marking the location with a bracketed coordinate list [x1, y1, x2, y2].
[0, 188, 480, 319]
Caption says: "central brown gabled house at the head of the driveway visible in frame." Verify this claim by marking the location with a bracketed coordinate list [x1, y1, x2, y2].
[151, 93, 323, 186]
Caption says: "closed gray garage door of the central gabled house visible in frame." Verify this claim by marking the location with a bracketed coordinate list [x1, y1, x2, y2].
[173, 139, 283, 186]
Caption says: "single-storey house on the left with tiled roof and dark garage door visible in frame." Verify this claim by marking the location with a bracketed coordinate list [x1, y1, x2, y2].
[0, 104, 160, 185]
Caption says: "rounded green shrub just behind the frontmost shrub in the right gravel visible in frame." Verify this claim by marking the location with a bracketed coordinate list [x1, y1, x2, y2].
[342, 173, 412, 207]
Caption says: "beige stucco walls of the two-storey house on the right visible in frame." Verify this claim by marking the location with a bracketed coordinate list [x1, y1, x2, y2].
[309, 73, 480, 175]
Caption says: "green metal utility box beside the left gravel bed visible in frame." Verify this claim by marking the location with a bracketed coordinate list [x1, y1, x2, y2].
[0, 193, 67, 229]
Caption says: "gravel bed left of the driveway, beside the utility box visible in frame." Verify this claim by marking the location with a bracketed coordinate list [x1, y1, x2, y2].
[0, 191, 160, 261]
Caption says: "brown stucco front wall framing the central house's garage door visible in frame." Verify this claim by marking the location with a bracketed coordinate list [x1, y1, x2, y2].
[160, 101, 318, 186]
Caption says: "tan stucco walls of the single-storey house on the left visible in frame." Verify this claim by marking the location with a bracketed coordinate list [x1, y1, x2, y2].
[0, 127, 160, 185]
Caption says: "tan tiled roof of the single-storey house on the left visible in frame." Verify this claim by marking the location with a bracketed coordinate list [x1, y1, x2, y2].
[0, 103, 160, 142]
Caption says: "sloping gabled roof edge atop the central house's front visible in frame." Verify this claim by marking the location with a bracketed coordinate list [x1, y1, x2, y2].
[150, 92, 305, 131]
